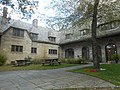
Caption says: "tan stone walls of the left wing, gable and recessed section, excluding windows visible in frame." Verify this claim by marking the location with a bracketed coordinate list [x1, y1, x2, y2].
[1, 28, 58, 64]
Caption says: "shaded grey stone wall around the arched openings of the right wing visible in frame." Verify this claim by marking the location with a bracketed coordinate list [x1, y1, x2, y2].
[60, 34, 120, 62]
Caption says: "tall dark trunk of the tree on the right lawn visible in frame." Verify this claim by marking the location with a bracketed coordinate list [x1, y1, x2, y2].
[92, 0, 100, 70]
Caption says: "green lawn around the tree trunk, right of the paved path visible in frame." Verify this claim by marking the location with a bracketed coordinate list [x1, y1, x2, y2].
[70, 64, 120, 86]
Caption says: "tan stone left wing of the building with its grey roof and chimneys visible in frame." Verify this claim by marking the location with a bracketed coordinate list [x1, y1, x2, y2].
[0, 7, 59, 64]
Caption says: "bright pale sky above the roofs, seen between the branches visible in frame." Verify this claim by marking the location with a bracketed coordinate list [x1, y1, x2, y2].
[0, 0, 77, 30]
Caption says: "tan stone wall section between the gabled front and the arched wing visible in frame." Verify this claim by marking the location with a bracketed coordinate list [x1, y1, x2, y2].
[31, 42, 59, 59]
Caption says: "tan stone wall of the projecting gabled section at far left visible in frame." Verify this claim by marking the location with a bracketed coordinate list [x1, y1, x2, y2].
[1, 28, 31, 64]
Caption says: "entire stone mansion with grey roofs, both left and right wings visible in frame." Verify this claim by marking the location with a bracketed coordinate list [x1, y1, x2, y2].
[0, 9, 120, 64]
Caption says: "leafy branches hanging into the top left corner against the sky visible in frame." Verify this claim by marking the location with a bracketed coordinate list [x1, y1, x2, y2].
[0, 0, 39, 20]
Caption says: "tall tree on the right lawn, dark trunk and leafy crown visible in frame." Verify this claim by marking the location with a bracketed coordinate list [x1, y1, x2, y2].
[45, 0, 120, 70]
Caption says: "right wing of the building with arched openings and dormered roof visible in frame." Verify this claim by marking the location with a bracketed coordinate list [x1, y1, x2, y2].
[59, 20, 120, 62]
